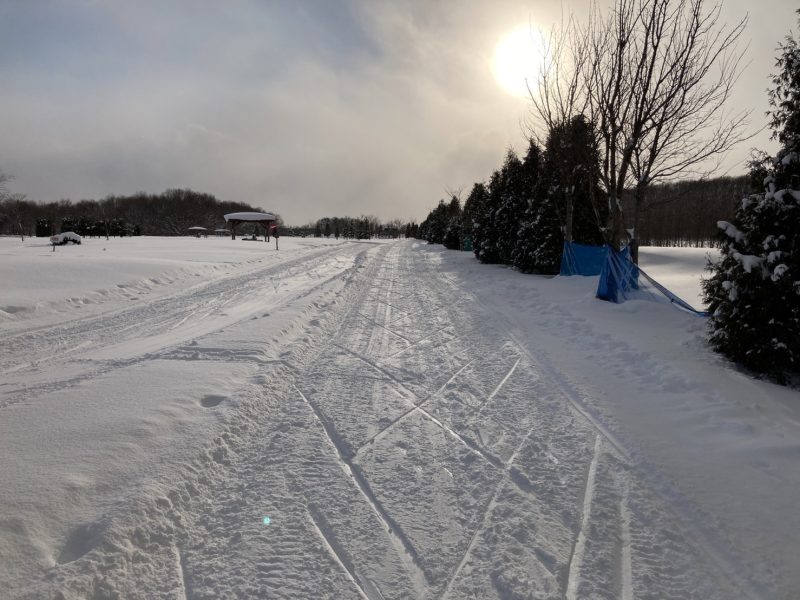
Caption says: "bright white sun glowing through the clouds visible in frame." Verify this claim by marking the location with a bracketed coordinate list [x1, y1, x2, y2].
[492, 23, 542, 98]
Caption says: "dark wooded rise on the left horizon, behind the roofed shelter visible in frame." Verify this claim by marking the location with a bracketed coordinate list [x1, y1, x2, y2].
[0, 189, 262, 236]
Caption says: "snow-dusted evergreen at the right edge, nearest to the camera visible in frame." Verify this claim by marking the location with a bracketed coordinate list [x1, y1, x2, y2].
[703, 11, 800, 382]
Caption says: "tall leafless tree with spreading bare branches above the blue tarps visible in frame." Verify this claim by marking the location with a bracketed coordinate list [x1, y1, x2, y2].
[531, 0, 749, 259]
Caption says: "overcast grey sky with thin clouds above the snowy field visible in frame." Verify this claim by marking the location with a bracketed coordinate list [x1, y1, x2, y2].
[0, 0, 797, 224]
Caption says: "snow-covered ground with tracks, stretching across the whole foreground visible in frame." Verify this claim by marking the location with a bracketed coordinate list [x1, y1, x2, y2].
[0, 238, 800, 600]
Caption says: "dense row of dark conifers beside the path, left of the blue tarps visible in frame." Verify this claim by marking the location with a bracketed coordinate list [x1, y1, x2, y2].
[417, 116, 606, 273]
